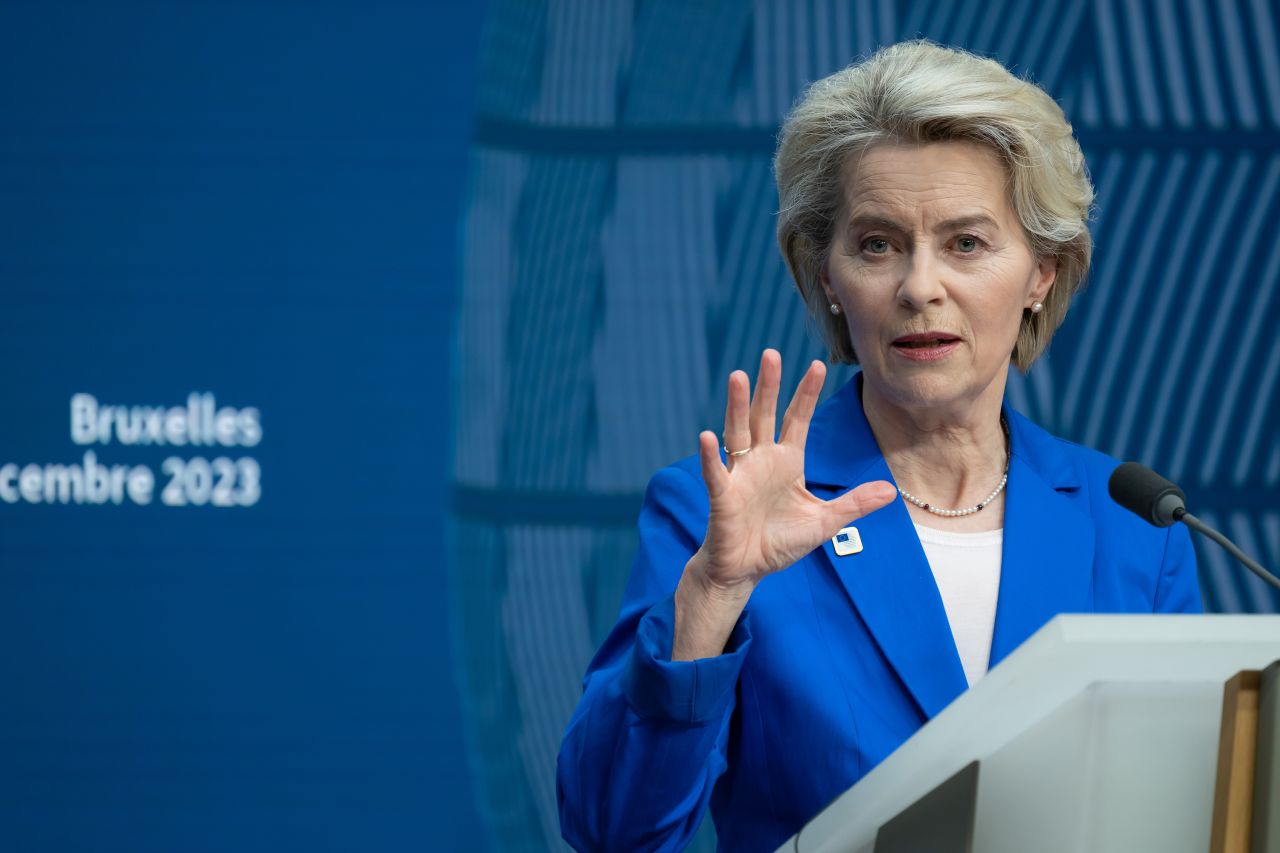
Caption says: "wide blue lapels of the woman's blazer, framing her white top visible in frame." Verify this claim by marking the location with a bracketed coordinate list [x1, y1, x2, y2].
[805, 374, 1094, 717]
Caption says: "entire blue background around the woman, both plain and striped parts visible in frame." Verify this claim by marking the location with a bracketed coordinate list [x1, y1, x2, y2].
[0, 0, 1280, 852]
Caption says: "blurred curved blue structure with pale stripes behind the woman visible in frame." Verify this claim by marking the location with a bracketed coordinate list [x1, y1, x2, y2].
[451, 0, 1280, 850]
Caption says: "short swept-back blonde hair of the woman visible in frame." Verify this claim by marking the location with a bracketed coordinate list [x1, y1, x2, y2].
[773, 40, 1093, 371]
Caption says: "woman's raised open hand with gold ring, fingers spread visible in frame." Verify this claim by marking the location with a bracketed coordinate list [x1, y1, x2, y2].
[673, 350, 897, 660]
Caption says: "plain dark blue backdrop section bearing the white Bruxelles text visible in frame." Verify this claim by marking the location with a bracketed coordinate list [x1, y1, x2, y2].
[0, 0, 484, 853]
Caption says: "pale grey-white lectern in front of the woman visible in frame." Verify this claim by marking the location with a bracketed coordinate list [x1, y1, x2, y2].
[780, 615, 1280, 853]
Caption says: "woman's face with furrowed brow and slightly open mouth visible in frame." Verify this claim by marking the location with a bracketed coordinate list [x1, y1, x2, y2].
[822, 142, 1056, 422]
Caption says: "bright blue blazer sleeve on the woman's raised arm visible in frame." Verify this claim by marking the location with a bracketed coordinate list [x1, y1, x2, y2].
[556, 467, 751, 850]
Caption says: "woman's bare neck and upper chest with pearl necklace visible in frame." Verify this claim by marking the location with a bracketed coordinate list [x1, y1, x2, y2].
[863, 380, 1009, 530]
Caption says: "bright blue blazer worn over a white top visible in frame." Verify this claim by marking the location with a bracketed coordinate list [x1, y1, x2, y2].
[557, 377, 1201, 850]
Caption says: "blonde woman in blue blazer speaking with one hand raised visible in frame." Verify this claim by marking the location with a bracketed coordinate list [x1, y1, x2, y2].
[558, 42, 1199, 850]
